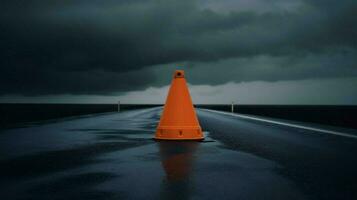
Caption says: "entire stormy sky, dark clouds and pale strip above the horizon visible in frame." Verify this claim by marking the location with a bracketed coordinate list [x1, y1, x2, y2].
[0, 0, 357, 104]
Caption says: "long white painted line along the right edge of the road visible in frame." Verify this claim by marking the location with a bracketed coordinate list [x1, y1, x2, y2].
[201, 109, 357, 139]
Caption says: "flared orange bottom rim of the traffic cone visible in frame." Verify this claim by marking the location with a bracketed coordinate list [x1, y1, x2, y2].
[154, 127, 204, 140]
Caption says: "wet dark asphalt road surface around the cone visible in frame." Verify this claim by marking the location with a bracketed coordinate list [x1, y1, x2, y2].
[0, 108, 357, 200]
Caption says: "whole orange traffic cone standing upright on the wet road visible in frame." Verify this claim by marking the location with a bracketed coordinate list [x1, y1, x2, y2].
[155, 70, 203, 140]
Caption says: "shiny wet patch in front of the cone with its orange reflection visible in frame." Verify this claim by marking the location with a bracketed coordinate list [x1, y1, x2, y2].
[87, 131, 303, 199]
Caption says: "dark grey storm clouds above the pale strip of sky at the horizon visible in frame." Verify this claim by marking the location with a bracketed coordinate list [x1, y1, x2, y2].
[0, 0, 357, 95]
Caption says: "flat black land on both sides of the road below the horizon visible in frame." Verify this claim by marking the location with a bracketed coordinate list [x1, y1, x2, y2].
[0, 104, 357, 129]
